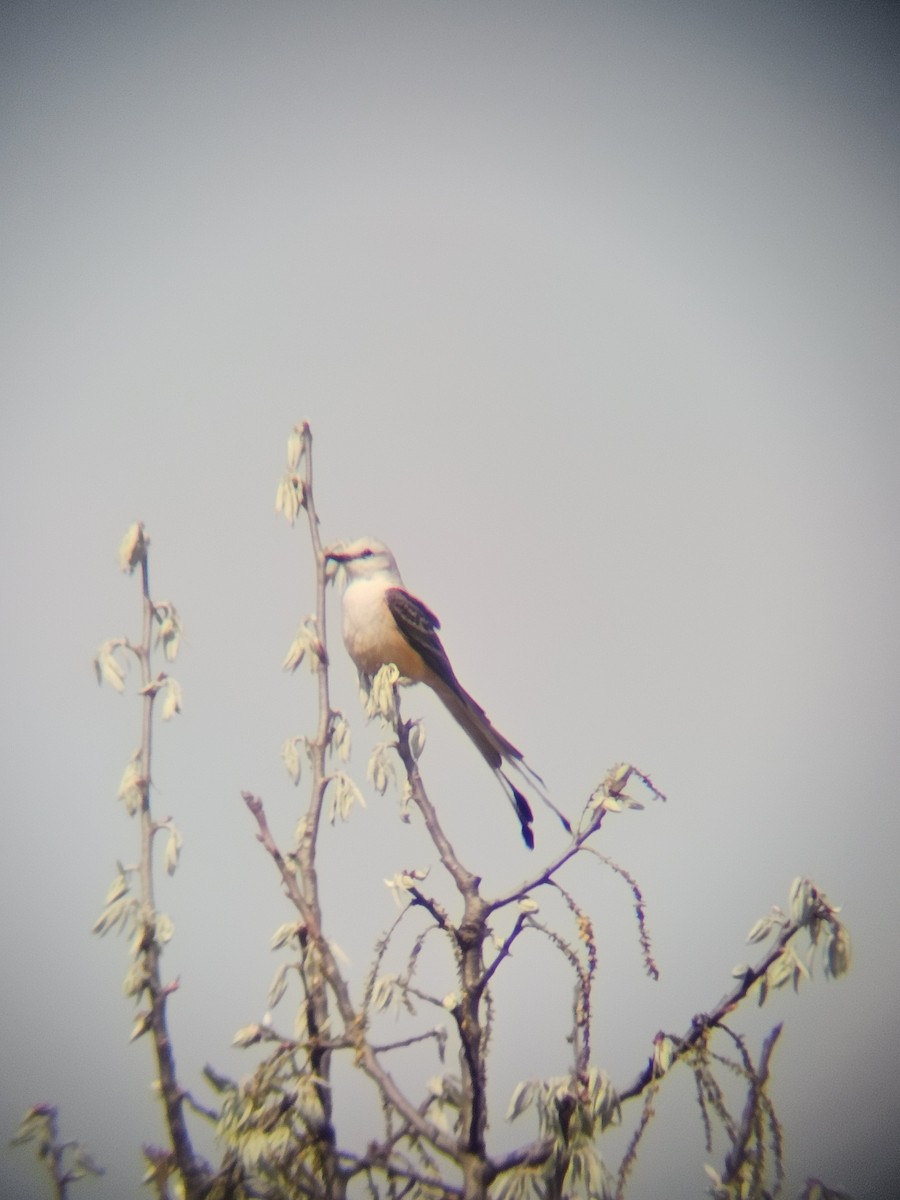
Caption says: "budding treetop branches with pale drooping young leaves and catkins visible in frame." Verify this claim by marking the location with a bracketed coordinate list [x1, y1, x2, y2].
[75, 422, 850, 1200]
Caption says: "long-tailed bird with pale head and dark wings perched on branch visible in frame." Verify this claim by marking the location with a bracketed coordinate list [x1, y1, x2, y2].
[328, 538, 571, 850]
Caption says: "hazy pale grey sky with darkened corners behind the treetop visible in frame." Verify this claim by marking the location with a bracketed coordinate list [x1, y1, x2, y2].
[0, 0, 900, 1200]
